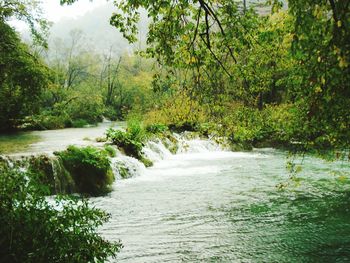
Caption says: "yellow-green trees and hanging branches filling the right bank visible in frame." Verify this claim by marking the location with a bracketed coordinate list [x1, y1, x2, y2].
[106, 0, 350, 156]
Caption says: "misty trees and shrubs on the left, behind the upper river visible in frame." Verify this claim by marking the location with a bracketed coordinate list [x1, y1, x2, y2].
[0, 0, 153, 133]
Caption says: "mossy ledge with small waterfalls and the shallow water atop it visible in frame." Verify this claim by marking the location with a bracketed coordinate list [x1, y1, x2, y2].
[1, 124, 224, 195]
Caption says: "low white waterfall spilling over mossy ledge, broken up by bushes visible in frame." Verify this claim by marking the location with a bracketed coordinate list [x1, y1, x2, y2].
[0, 132, 226, 188]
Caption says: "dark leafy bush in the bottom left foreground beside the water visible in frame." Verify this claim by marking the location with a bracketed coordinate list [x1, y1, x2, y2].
[0, 167, 122, 262]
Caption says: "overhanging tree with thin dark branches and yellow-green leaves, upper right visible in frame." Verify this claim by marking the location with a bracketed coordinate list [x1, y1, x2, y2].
[61, 0, 350, 151]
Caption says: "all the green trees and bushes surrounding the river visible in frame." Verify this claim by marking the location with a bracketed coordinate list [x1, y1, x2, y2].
[0, 0, 350, 262]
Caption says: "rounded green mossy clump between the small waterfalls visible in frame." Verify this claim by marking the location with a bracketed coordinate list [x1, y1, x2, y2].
[55, 146, 114, 195]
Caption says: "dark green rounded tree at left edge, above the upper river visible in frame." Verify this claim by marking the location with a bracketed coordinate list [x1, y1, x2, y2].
[0, 18, 49, 132]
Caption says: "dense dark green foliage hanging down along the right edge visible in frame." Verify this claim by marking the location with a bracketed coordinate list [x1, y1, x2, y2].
[289, 0, 350, 152]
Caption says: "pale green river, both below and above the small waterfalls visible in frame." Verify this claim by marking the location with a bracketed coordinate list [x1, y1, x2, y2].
[0, 124, 350, 263]
